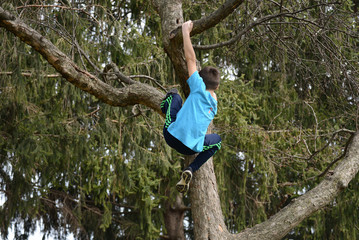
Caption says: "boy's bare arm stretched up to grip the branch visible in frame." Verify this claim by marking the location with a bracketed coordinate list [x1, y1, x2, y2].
[182, 20, 197, 76]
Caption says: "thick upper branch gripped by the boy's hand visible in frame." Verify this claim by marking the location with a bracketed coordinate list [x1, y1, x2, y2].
[170, 0, 244, 39]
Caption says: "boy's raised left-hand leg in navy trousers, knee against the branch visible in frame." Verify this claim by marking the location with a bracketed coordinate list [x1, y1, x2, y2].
[161, 93, 182, 128]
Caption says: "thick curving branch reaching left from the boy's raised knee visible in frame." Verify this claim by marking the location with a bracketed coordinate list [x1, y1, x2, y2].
[0, 7, 164, 113]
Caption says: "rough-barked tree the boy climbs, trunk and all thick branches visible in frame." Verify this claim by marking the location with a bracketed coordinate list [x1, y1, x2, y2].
[0, 0, 359, 239]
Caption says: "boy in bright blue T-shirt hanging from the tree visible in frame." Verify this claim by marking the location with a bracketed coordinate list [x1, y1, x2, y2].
[161, 21, 221, 193]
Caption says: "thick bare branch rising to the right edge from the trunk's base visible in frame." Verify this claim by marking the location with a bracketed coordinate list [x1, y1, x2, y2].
[233, 132, 359, 240]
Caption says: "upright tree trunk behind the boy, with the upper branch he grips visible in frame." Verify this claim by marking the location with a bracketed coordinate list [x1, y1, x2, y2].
[153, 0, 243, 239]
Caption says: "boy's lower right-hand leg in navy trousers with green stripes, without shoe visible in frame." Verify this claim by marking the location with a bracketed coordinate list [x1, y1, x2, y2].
[189, 134, 222, 172]
